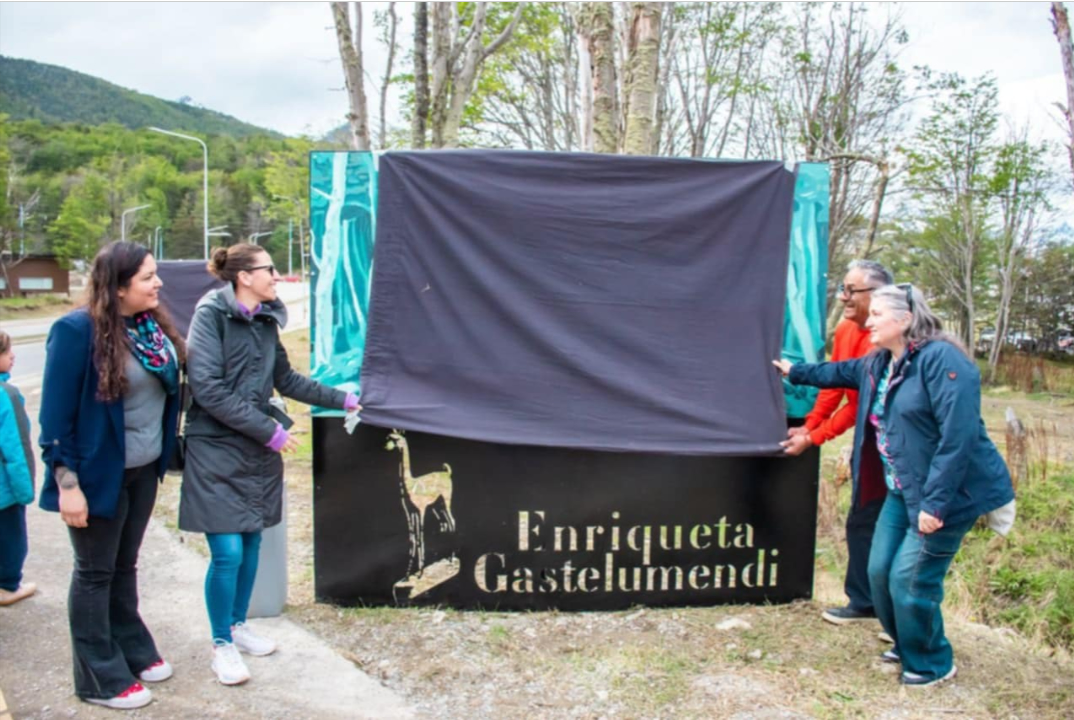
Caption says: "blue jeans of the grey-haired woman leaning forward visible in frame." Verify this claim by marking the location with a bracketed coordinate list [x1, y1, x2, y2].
[869, 492, 975, 679]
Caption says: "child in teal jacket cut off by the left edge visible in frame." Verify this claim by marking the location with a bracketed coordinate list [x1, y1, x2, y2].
[0, 331, 38, 606]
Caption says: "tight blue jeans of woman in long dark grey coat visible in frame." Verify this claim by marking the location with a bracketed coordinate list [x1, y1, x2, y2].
[205, 531, 261, 643]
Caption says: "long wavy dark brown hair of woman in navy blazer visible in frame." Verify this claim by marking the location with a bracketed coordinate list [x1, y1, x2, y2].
[86, 241, 187, 402]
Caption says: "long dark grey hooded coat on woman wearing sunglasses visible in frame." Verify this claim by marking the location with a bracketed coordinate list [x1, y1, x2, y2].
[179, 285, 346, 533]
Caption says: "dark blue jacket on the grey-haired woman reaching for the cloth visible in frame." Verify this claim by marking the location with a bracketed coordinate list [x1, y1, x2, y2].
[789, 340, 1014, 528]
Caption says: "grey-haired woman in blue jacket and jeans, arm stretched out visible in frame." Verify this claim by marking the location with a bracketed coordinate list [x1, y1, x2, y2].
[774, 285, 1014, 687]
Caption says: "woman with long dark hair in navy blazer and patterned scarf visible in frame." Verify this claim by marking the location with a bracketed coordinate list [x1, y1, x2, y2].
[39, 242, 185, 709]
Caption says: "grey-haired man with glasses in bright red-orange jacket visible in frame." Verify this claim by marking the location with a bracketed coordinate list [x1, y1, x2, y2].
[782, 260, 895, 625]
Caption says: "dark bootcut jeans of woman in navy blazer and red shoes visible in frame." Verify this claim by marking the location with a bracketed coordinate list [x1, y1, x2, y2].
[68, 462, 160, 699]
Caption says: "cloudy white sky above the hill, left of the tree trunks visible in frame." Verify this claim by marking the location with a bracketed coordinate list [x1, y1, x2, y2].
[0, 2, 409, 134]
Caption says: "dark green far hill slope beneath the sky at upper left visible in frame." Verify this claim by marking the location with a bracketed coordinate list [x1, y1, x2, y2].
[0, 56, 279, 136]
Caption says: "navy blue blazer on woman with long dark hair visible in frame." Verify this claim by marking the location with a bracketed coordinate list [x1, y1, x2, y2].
[38, 308, 179, 518]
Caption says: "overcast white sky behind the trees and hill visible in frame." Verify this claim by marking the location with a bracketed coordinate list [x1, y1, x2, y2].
[0, 2, 1065, 145]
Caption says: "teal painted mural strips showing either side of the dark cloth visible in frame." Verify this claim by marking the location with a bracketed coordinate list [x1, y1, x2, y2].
[309, 153, 828, 417]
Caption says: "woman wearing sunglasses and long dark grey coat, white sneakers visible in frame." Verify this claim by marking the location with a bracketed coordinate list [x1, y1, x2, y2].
[179, 243, 358, 685]
